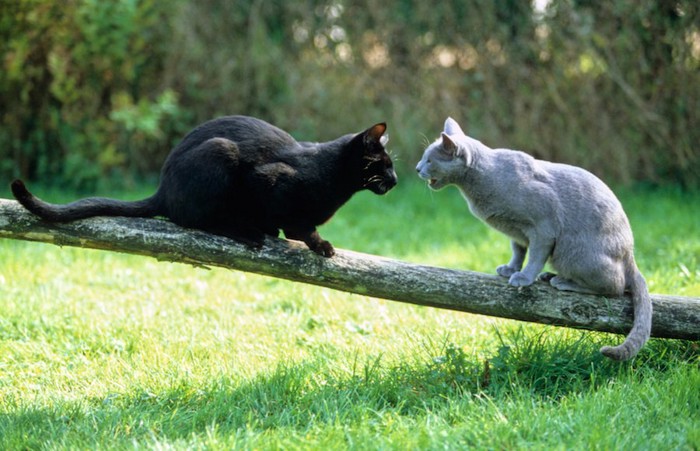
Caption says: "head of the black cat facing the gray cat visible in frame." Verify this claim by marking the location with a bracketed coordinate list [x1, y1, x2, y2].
[355, 122, 397, 194]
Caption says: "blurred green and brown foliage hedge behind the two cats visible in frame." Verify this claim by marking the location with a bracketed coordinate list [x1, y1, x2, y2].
[0, 0, 700, 189]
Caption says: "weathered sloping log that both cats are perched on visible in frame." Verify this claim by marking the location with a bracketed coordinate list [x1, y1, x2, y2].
[0, 199, 700, 340]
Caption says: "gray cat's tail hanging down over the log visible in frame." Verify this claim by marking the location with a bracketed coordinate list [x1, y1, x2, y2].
[600, 270, 652, 360]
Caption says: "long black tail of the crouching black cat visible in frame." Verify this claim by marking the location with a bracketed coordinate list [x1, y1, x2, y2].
[10, 180, 163, 222]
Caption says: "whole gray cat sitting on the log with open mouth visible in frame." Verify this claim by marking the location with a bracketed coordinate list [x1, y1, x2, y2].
[416, 118, 652, 360]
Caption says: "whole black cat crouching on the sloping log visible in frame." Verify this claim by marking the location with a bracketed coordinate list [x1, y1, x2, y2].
[12, 116, 396, 257]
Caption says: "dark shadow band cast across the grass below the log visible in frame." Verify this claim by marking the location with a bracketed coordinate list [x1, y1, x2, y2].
[0, 328, 700, 449]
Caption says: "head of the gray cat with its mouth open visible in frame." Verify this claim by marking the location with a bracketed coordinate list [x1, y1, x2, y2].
[416, 117, 479, 190]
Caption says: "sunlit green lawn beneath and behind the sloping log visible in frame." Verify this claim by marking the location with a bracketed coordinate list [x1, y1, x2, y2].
[0, 180, 700, 450]
